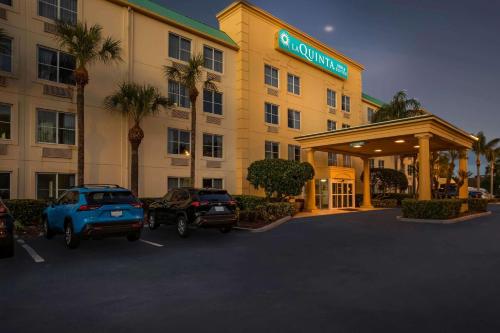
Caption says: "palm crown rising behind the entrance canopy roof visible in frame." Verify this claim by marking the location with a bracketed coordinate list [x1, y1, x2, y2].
[373, 91, 425, 123]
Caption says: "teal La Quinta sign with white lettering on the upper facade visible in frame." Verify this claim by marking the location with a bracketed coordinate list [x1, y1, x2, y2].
[277, 29, 347, 79]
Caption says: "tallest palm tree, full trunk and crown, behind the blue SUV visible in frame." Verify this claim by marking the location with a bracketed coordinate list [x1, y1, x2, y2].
[56, 21, 122, 185]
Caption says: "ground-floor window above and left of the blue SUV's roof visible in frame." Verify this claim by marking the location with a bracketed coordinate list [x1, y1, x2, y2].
[36, 173, 75, 199]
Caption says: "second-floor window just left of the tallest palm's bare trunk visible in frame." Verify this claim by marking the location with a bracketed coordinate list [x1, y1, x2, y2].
[36, 109, 76, 145]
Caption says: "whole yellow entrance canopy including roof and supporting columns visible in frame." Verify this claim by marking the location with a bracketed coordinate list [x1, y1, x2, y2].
[295, 114, 477, 210]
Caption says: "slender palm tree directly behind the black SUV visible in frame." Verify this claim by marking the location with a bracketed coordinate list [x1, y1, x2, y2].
[164, 54, 217, 186]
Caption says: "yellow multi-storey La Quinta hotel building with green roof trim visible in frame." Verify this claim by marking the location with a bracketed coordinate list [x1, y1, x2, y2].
[0, 0, 406, 208]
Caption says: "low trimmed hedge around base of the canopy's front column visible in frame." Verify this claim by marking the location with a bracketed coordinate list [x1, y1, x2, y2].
[402, 199, 462, 220]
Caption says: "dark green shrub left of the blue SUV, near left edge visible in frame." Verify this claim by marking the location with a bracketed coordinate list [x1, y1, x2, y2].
[4, 199, 47, 226]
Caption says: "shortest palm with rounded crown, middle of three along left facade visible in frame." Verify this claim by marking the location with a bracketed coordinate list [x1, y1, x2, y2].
[104, 82, 169, 195]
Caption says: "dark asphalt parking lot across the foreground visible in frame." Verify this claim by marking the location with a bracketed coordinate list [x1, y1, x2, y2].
[0, 206, 500, 333]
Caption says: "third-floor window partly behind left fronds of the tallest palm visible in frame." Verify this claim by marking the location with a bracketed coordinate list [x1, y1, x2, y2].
[38, 46, 76, 85]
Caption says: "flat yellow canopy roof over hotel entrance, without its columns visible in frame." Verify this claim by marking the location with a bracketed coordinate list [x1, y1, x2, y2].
[295, 114, 477, 157]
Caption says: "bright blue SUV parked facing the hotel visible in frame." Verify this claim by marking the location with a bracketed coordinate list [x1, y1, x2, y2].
[42, 184, 144, 249]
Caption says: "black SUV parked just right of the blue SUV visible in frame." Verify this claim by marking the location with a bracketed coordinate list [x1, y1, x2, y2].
[147, 187, 237, 237]
